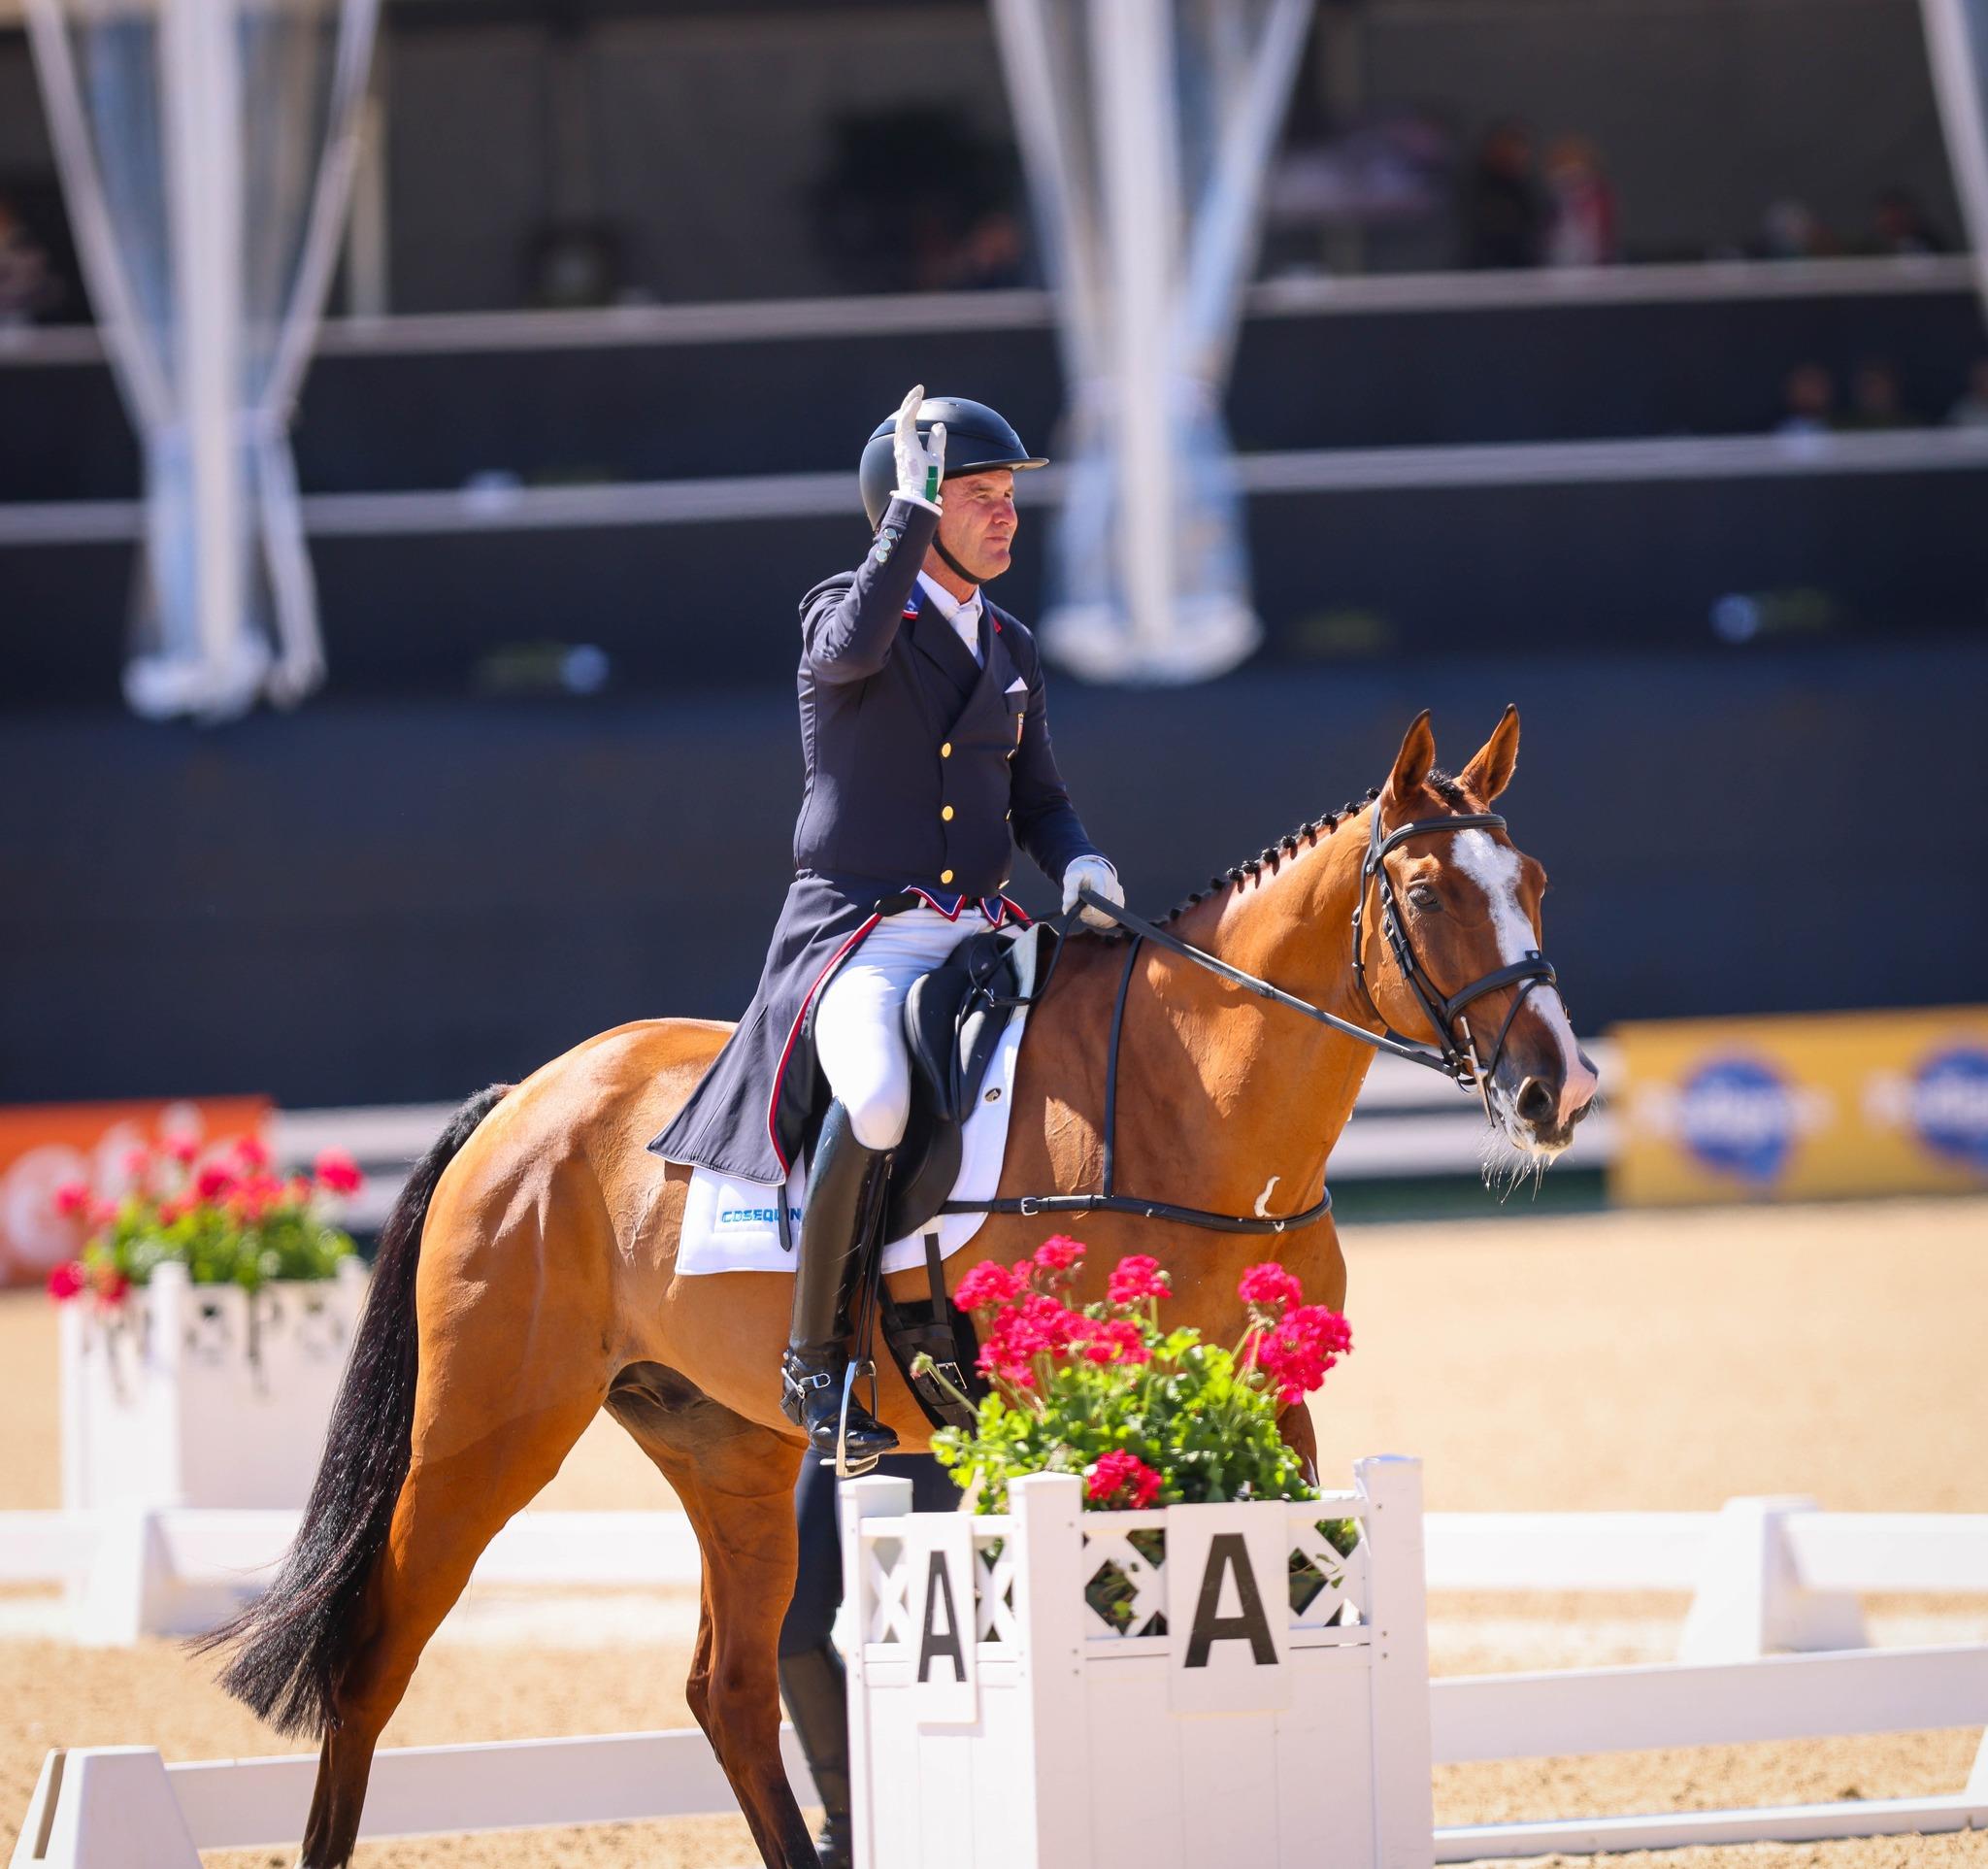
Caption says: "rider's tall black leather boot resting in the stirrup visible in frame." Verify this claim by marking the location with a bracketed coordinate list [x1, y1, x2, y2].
[779, 1104, 897, 1465]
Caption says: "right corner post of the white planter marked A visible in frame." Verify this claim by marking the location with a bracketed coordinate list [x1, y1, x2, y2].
[1354, 1453, 1436, 1869]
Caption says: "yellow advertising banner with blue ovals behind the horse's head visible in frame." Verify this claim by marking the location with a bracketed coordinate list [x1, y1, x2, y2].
[1608, 1006, 1988, 1205]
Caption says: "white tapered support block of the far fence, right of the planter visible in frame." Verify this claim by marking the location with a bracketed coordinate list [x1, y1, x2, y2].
[1678, 1497, 1869, 1662]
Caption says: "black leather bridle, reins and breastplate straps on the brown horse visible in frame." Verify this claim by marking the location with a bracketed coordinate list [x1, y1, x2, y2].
[939, 803, 1555, 1233]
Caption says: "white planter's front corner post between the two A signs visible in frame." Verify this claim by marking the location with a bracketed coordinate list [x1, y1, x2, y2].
[1008, 1473, 1095, 1869]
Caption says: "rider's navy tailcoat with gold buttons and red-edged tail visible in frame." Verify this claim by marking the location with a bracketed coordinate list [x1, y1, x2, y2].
[650, 499, 1097, 1183]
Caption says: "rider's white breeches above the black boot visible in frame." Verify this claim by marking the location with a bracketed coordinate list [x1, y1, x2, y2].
[815, 905, 986, 1150]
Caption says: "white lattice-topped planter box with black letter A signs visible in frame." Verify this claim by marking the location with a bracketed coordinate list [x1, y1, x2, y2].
[843, 1459, 1434, 1869]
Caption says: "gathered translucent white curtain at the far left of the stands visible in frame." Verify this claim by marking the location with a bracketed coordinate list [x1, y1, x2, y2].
[28, 0, 378, 718]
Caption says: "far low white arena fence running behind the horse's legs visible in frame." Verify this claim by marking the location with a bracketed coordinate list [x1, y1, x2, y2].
[0, 1497, 1988, 1664]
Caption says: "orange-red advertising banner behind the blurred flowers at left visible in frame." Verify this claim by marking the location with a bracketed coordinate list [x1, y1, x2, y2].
[0, 1097, 271, 1285]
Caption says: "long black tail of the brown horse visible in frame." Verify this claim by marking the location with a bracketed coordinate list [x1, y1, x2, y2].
[199, 1084, 511, 1736]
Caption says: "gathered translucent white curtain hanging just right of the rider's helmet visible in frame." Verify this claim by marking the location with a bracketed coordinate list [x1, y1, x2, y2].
[994, 0, 1312, 682]
